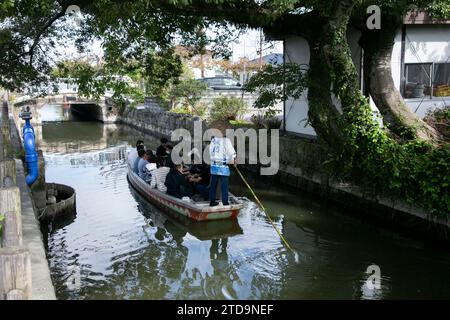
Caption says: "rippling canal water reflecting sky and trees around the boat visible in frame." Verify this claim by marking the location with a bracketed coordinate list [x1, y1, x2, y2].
[39, 106, 450, 299]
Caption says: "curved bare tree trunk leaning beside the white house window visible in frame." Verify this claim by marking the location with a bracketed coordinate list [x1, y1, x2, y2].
[360, 13, 439, 143]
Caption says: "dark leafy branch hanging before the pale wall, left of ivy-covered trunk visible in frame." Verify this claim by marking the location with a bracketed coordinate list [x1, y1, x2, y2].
[244, 63, 307, 108]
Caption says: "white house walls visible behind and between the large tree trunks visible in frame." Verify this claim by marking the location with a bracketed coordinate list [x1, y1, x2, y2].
[284, 25, 450, 136]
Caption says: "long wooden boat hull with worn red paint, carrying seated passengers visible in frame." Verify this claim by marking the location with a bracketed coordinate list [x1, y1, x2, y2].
[127, 165, 243, 221]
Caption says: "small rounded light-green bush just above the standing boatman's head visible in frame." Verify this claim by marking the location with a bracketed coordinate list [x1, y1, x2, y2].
[209, 96, 247, 121]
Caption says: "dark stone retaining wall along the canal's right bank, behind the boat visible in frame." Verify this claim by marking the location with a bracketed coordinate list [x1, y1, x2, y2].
[118, 108, 450, 243]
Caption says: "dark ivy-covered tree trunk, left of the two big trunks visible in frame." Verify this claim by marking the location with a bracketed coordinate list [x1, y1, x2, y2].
[307, 0, 362, 154]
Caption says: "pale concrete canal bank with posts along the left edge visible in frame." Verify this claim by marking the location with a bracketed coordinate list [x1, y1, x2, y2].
[0, 106, 56, 300]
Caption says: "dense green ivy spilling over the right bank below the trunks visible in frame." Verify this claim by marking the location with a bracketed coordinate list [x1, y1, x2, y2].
[333, 95, 450, 216]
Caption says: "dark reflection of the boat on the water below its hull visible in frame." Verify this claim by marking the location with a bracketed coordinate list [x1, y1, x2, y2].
[128, 184, 243, 240]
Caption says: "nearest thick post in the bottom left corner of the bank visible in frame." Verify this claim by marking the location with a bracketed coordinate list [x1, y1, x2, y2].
[0, 247, 31, 300]
